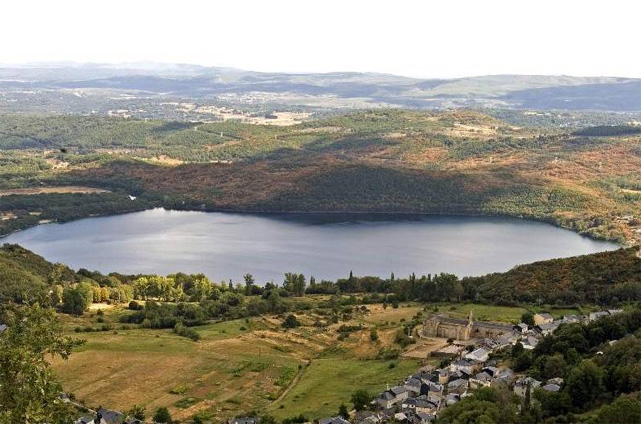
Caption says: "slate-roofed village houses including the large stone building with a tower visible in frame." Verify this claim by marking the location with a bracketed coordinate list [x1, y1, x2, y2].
[69, 309, 622, 424]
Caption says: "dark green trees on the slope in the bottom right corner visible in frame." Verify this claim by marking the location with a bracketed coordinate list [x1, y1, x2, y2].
[512, 309, 641, 423]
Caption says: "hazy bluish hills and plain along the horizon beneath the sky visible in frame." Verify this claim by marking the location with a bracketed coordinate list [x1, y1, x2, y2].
[0, 63, 641, 112]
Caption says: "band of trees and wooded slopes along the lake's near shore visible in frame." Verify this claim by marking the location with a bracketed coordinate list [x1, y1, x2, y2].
[5, 245, 641, 320]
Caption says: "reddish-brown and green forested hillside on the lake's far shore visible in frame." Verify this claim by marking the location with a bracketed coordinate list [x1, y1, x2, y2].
[0, 110, 641, 244]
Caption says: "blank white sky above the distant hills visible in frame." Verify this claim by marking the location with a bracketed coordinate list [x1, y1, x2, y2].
[5, 0, 641, 78]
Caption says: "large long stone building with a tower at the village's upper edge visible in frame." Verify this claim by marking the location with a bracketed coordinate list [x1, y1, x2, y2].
[423, 312, 512, 341]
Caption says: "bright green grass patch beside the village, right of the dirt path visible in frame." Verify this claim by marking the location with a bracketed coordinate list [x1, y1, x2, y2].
[269, 358, 420, 420]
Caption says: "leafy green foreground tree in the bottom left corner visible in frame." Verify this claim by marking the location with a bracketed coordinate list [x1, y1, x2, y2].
[0, 304, 82, 424]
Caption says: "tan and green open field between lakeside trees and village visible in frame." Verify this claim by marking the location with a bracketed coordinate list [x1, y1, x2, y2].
[54, 302, 430, 419]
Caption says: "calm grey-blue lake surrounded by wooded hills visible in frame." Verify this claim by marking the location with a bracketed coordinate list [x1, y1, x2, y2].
[0, 209, 618, 283]
